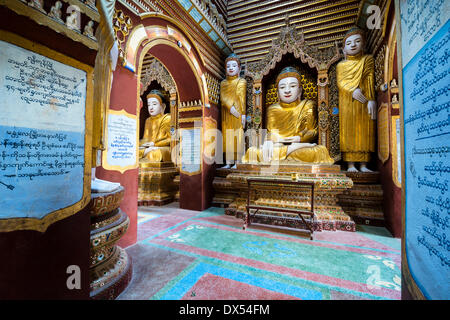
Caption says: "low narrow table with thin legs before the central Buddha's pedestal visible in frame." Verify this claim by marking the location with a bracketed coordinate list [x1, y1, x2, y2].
[243, 178, 314, 240]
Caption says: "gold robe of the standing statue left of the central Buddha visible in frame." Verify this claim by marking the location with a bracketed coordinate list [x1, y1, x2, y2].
[220, 76, 247, 159]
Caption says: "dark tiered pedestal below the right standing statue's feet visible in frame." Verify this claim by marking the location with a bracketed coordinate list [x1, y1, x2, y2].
[339, 172, 384, 226]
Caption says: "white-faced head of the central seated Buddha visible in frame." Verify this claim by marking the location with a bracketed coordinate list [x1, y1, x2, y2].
[276, 67, 302, 103]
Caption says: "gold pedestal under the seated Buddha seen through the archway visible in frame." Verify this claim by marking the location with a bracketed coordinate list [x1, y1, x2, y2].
[138, 161, 178, 206]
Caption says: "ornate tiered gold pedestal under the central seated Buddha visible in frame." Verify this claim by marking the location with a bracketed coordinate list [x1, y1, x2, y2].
[221, 162, 355, 231]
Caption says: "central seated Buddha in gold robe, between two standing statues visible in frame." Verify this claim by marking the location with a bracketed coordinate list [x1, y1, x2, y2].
[242, 67, 334, 164]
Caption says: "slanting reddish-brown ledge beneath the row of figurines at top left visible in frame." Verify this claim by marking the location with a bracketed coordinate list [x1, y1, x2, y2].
[0, 0, 100, 50]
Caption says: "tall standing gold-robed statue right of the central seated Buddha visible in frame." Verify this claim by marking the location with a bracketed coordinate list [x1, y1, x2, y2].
[336, 28, 377, 172]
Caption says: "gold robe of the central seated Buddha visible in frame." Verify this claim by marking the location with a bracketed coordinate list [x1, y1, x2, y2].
[242, 100, 334, 164]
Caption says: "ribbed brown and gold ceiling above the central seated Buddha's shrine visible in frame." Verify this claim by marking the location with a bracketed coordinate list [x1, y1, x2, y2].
[227, 0, 362, 62]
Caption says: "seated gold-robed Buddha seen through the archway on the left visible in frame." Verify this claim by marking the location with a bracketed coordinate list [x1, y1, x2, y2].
[139, 90, 171, 162]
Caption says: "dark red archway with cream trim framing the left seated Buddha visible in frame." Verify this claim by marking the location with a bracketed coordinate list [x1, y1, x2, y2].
[97, 8, 214, 246]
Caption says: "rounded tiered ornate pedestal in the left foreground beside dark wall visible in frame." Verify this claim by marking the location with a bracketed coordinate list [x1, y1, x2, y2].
[89, 187, 132, 300]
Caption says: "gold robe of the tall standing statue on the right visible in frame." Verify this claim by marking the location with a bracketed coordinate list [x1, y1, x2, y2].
[336, 54, 375, 162]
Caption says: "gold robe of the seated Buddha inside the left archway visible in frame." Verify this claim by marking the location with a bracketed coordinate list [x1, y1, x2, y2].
[139, 113, 171, 162]
